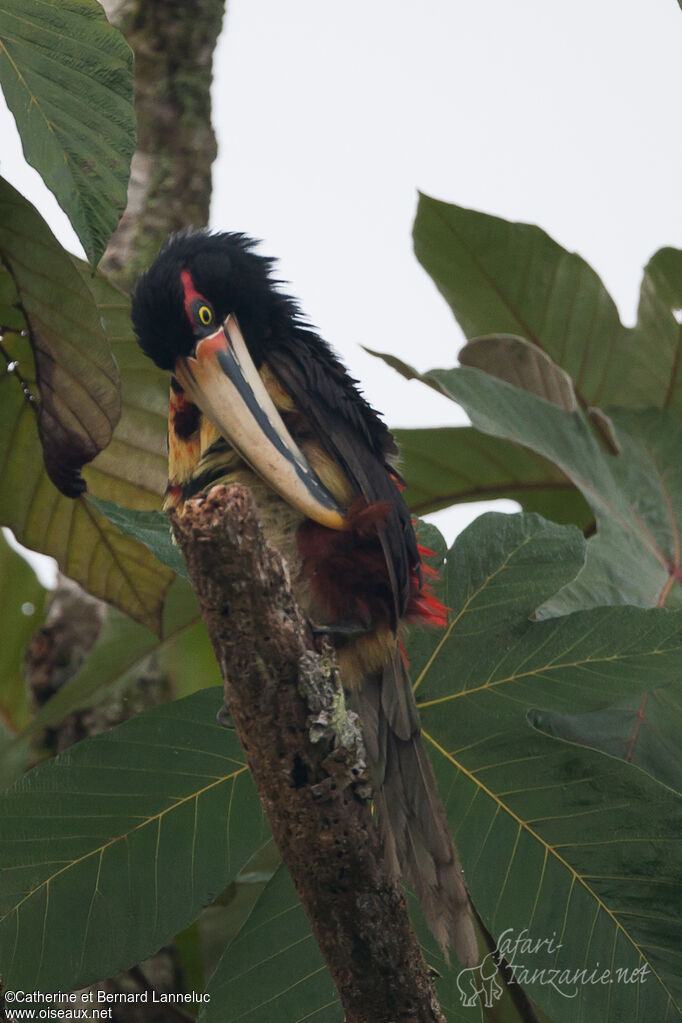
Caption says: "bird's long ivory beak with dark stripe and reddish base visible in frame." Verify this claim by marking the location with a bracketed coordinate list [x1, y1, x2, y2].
[175, 315, 346, 529]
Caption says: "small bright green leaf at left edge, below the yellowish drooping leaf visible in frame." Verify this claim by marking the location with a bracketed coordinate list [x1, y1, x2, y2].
[0, 533, 45, 736]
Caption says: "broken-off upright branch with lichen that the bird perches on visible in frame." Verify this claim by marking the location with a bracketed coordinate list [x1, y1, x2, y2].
[172, 485, 444, 1023]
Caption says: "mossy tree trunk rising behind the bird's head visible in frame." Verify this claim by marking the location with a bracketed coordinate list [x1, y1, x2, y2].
[101, 0, 225, 288]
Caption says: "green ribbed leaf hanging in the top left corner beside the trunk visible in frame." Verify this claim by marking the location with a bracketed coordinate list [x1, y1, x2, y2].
[0, 0, 135, 265]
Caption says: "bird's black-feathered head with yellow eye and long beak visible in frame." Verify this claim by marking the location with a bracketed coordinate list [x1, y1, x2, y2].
[132, 231, 345, 529]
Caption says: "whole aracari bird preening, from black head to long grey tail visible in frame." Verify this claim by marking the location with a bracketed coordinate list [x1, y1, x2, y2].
[132, 231, 476, 965]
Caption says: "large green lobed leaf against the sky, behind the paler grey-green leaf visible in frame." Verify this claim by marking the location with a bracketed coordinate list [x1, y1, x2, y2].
[372, 195, 682, 526]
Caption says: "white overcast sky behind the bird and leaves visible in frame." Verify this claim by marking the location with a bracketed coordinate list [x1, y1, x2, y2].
[0, 0, 682, 585]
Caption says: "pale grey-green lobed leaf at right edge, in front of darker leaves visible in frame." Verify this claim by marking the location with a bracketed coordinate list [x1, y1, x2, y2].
[394, 367, 682, 615]
